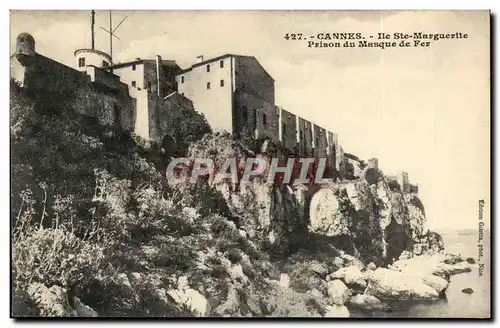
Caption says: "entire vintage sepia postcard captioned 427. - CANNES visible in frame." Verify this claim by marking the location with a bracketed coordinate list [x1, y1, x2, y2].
[10, 10, 492, 320]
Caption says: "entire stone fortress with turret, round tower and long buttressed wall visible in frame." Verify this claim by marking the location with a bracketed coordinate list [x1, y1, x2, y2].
[10, 19, 418, 193]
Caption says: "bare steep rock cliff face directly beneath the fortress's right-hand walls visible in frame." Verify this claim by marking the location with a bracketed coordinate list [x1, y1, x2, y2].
[188, 135, 443, 264]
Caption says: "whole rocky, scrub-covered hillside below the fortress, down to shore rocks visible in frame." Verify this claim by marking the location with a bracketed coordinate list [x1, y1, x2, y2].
[11, 83, 470, 317]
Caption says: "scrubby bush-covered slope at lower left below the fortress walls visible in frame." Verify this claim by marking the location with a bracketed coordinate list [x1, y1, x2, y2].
[10, 80, 336, 317]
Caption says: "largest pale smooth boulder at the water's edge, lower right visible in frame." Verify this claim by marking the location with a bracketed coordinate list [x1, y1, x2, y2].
[365, 268, 439, 301]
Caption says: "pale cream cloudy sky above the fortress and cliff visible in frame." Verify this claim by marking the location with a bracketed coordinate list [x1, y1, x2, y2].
[11, 11, 490, 229]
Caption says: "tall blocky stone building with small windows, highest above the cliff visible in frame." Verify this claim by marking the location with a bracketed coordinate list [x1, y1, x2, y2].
[176, 54, 279, 141]
